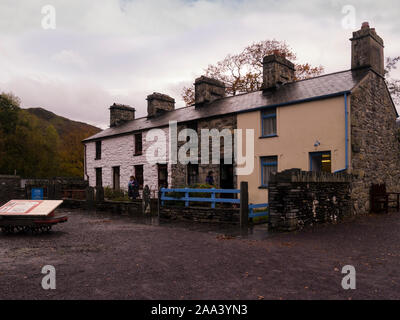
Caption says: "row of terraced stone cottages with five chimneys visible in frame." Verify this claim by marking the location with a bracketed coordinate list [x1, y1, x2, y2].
[83, 23, 400, 212]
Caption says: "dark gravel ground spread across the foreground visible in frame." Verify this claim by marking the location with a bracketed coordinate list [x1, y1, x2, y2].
[0, 210, 400, 299]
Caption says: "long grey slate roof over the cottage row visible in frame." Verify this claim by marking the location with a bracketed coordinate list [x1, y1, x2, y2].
[83, 68, 369, 142]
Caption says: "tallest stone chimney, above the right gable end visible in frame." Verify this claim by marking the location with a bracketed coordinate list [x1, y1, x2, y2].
[350, 22, 385, 76]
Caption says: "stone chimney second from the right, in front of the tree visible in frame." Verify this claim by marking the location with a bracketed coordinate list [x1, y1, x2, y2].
[262, 54, 295, 89]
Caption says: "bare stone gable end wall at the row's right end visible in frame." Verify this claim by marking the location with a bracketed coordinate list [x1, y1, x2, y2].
[350, 71, 400, 214]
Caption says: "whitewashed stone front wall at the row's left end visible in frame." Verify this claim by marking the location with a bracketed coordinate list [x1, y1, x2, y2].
[86, 128, 171, 194]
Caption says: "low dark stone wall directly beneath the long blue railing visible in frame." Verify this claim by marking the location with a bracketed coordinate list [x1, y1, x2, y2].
[160, 206, 240, 224]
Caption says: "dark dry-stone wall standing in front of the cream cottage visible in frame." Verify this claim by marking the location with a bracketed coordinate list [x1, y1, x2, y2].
[268, 169, 352, 231]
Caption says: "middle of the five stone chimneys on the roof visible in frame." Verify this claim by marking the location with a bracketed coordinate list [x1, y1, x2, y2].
[194, 76, 225, 106]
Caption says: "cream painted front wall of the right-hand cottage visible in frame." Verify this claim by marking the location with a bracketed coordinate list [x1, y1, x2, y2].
[237, 96, 351, 203]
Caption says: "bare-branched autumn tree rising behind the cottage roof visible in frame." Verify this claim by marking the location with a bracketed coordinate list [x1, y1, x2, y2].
[182, 40, 324, 106]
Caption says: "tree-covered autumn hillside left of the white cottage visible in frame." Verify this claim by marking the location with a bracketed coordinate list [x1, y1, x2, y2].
[0, 93, 101, 178]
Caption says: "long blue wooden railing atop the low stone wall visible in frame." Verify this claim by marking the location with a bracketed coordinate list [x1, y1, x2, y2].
[160, 188, 240, 208]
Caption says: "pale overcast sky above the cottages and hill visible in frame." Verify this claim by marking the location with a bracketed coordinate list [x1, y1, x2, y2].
[0, 0, 400, 128]
